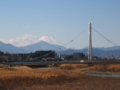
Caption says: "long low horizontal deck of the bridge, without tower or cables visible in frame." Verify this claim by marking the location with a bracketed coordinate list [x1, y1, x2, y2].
[5, 60, 120, 65]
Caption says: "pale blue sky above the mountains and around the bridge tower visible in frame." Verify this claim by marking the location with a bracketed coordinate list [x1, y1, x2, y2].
[0, 0, 120, 49]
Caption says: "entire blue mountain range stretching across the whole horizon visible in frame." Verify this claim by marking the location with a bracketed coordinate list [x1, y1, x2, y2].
[0, 41, 120, 58]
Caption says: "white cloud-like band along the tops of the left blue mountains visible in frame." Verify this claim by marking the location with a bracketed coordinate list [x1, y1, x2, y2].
[0, 34, 61, 47]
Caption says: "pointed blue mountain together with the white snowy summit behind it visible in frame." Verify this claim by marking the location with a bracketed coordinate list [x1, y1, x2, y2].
[21, 36, 67, 52]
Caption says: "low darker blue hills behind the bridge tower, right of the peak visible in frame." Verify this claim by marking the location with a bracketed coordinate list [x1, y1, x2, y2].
[57, 47, 120, 58]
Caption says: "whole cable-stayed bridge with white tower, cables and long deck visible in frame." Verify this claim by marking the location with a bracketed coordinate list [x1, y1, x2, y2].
[5, 23, 120, 65]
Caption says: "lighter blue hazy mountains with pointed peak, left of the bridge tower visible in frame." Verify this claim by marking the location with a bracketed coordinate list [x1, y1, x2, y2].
[0, 41, 67, 53]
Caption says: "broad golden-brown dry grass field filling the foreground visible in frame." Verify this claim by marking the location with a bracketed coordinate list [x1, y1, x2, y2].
[0, 64, 120, 90]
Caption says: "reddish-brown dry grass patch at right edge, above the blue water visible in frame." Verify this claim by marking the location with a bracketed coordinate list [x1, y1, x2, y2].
[89, 64, 120, 72]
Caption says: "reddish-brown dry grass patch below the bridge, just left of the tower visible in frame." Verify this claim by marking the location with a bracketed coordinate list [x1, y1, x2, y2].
[60, 64, 88, 70]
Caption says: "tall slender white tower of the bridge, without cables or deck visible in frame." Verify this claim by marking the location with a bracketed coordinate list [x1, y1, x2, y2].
[88, 23, 92, 61]
